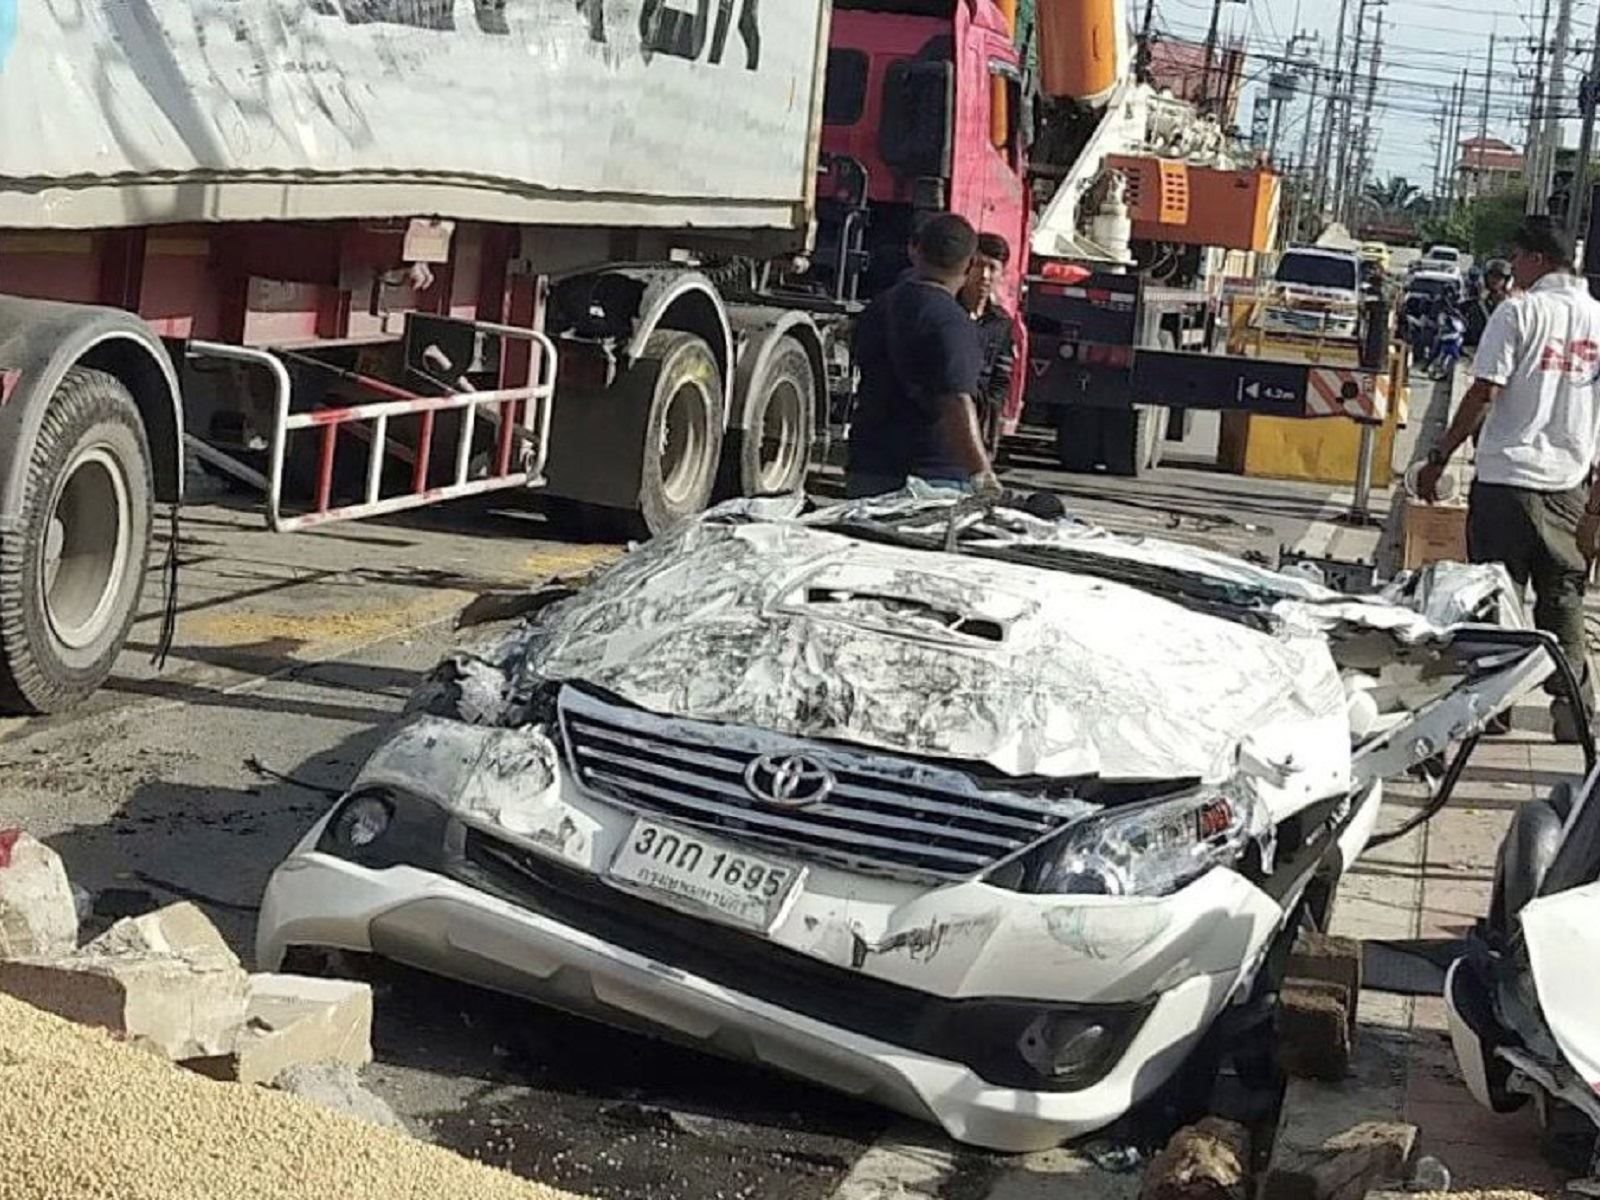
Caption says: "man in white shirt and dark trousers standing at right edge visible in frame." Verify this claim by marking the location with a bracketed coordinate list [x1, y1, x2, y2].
[1418, 216, 1600, 741]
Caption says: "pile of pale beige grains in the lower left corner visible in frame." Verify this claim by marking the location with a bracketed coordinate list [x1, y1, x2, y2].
[0, 995, 588, 1200]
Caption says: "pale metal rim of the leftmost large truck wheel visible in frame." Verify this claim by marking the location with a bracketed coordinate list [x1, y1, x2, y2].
[40, 446, 133, 650]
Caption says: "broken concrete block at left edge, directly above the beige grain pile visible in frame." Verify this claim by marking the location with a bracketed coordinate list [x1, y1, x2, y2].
[0, 952, 250, 1059]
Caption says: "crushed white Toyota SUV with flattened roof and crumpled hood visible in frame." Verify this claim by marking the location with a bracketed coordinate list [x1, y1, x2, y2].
[258, 490, 1552, 1150]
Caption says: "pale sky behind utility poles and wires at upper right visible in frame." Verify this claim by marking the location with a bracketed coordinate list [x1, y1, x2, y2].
[1152, 0, 1600, 190]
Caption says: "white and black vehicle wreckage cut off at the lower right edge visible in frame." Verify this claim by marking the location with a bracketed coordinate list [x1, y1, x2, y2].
[1445, 732, 1600, 1194]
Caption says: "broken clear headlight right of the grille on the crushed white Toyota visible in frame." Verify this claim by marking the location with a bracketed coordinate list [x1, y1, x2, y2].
[1027, 790, 1270, 896]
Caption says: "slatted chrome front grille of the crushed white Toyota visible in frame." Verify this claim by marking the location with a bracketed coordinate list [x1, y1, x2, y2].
[560, 686, 1088, 878]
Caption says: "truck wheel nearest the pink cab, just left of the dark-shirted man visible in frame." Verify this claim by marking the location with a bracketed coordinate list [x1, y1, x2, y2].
[732, 338, 816, 496]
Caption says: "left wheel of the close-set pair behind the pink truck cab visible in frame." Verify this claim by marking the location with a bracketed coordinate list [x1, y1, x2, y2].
[618, 330, 723, 536]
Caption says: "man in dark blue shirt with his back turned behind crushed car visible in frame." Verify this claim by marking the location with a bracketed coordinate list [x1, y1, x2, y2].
[846, 213, 1000, 499]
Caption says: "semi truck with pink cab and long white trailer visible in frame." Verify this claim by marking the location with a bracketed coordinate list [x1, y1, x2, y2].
[0, 0, 1030, 712]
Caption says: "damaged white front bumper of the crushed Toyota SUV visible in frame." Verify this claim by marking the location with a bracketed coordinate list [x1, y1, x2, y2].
[258, 771, 1379, 1152]
